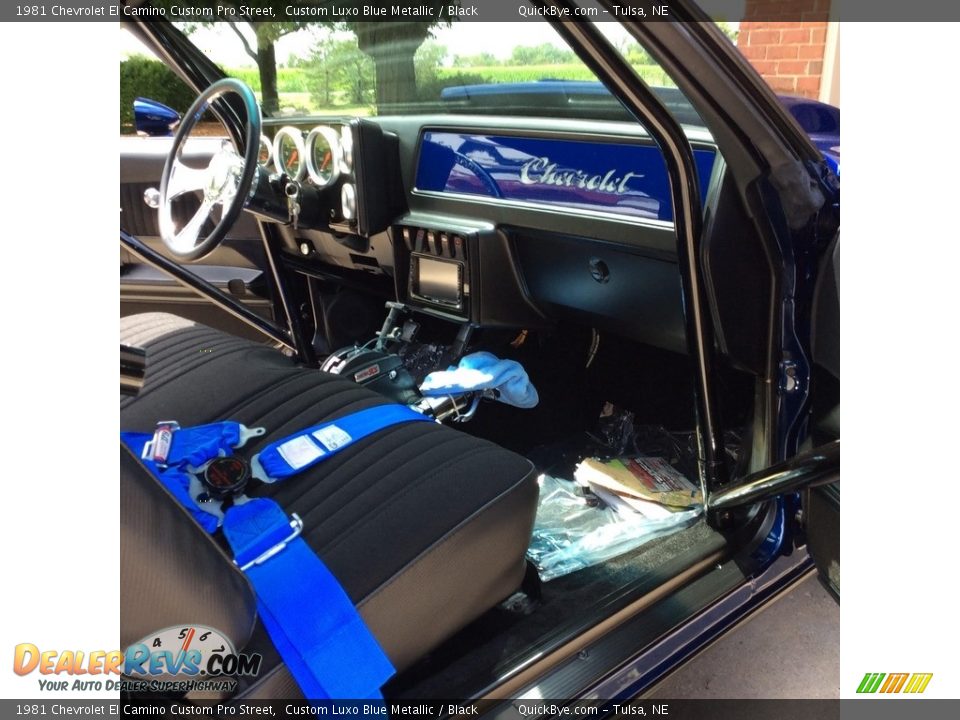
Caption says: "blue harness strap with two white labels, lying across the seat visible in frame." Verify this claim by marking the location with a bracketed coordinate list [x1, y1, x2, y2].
[250, 405, 434, 483]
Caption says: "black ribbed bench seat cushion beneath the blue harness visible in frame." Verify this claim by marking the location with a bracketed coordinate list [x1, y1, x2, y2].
[120, 314, 537, 688]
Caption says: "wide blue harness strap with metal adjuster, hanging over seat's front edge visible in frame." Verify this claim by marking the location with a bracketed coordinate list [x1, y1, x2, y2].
[223, 498, 394, 700]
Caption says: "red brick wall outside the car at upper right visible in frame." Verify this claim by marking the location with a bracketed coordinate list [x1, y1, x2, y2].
[737, 0, 830, 99]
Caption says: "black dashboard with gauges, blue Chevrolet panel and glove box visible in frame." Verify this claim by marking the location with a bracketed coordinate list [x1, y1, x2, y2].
[251, 115, 748, 360]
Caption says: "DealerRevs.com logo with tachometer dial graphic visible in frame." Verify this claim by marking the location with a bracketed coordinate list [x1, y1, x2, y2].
[13, 625, 263, 692]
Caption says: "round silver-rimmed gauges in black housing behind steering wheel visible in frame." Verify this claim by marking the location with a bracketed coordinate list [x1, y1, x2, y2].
[253, 118, 406, 237]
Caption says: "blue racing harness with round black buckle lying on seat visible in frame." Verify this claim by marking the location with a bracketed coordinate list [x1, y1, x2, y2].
[120, 405, 433, 700]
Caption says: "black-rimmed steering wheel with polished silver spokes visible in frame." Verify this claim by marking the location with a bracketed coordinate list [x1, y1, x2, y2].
[158, 78, 261, 261]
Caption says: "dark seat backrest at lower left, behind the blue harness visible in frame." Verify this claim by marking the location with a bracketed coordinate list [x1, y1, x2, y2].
[120, 445, 256, 651]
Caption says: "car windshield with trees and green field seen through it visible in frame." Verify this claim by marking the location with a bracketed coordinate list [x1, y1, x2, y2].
[121, 2, 736, 125]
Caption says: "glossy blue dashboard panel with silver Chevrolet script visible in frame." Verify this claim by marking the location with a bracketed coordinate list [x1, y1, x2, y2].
[416, 130, 716, 221]
